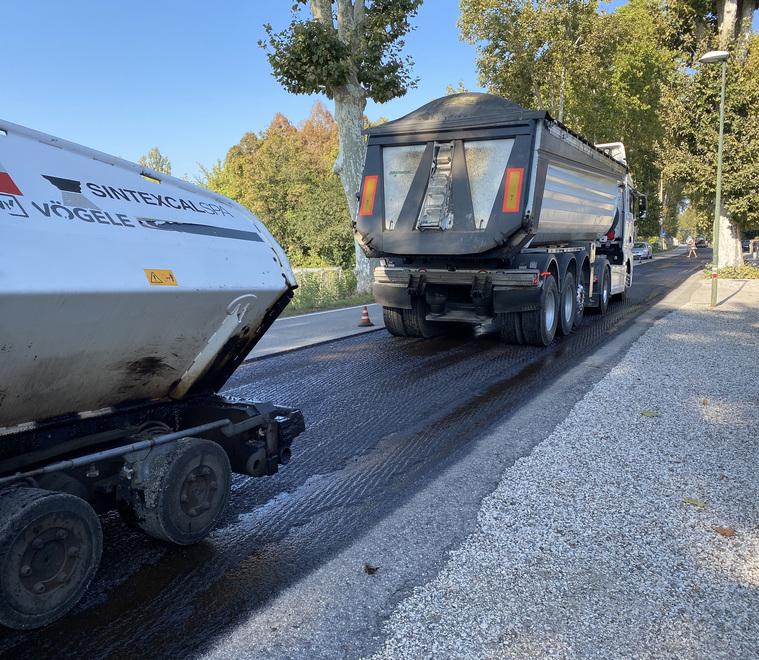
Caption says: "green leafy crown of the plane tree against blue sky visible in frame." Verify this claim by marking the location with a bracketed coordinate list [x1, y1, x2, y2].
[259, 0, 421, 103]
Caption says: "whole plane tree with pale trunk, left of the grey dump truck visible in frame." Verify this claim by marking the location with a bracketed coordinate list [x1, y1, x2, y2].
[261, 0, 421, 291]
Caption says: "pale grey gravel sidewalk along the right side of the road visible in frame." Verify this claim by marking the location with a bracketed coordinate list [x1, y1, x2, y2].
[377, 280, 759, 658]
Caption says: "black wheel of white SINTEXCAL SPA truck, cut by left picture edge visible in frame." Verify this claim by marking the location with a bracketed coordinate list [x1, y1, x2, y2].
[0, 488, 103, 630]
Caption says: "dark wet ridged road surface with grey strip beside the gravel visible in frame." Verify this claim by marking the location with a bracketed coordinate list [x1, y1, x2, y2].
[0, 251, 709, 658]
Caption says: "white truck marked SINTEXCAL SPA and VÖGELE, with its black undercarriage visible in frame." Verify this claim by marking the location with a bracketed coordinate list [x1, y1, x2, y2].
[0, 121, 304, 629]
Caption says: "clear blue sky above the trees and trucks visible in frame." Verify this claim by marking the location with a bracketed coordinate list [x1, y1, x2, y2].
[0, 0, 757, 176]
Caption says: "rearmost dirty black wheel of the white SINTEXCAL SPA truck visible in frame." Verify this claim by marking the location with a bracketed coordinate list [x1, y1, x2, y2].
[132, 438, 232, 545]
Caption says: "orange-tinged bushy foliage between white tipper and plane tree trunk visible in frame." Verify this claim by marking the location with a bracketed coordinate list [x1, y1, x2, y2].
[205, 103, 354, 268]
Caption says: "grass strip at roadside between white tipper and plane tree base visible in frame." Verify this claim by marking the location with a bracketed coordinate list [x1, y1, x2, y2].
[282, 269, 374, 316]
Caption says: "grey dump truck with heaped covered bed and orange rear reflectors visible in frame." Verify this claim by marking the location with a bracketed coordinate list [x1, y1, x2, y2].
[353, 93, 645, 346]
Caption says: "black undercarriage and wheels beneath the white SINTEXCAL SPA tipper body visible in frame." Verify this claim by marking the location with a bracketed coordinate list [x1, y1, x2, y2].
[0, 395, 304, 629]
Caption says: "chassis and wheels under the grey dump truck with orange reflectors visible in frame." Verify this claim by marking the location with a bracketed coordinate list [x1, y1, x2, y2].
[373, 242, 632, 346]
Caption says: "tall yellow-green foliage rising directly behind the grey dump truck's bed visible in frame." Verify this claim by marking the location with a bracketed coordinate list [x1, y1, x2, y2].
[459, 0, 675, 235]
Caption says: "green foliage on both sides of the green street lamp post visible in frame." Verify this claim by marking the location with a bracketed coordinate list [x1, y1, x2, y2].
[662, 35, 759, 228]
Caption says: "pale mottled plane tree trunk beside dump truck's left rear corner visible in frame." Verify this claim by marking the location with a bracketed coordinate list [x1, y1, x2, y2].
[334, 84, 372, 293]
